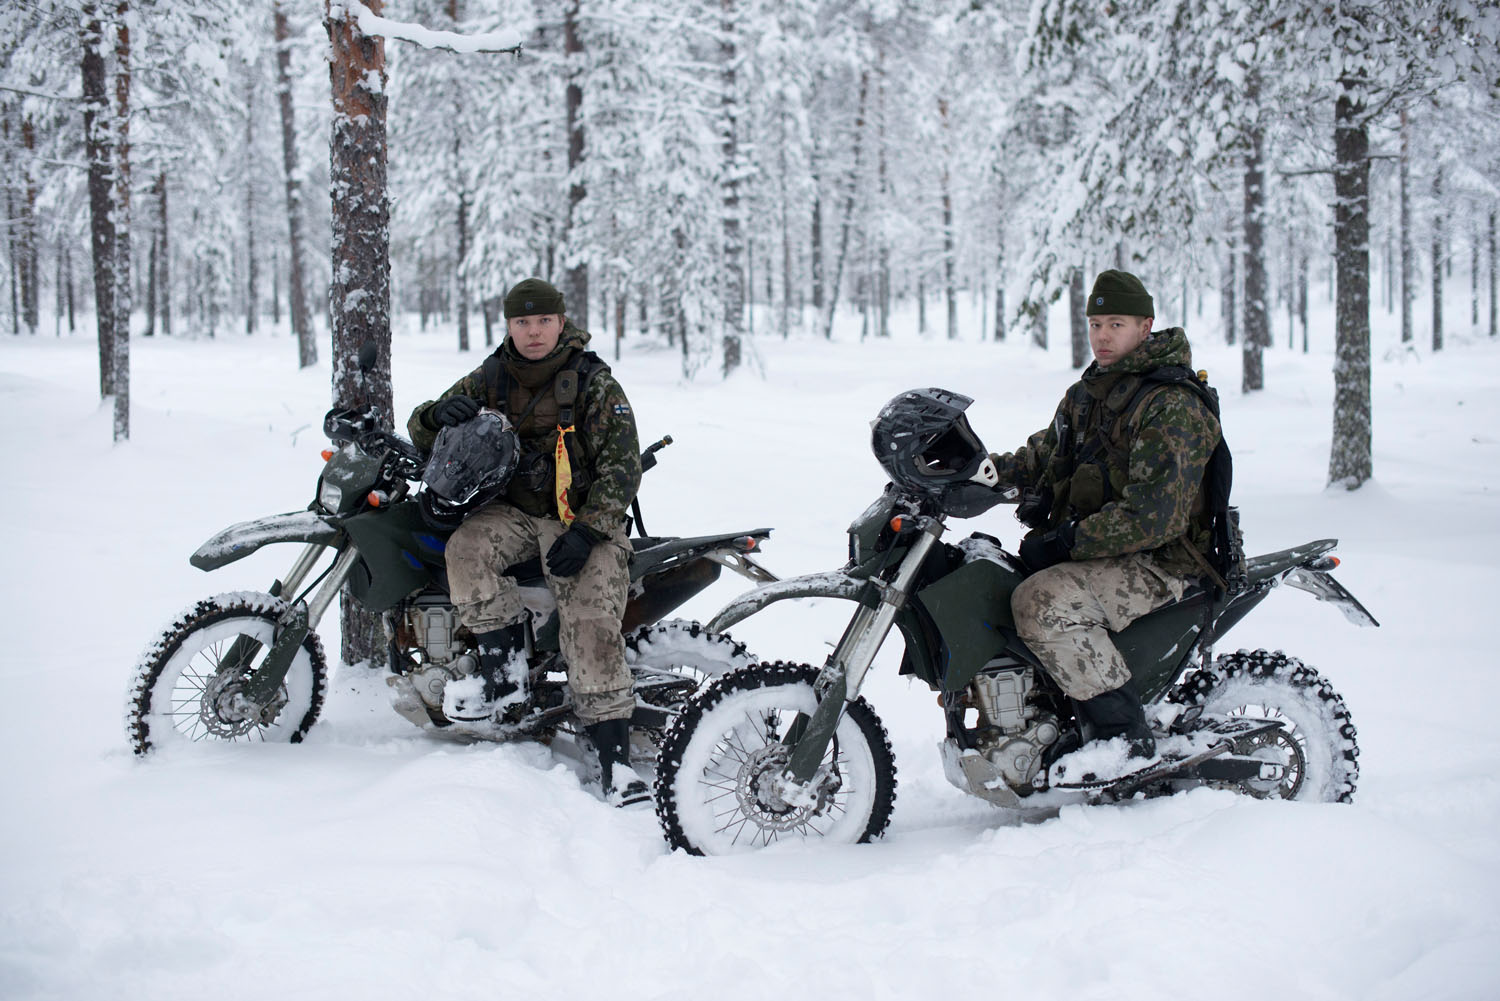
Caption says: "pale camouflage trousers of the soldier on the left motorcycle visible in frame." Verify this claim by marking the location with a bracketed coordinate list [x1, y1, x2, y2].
[446, 503, 636, 723]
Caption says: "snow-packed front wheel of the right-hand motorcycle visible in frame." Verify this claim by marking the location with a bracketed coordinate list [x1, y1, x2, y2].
[656, 663, 896, 855]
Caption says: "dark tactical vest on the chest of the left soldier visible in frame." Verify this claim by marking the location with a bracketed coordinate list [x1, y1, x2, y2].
[482, 351, 609, 518]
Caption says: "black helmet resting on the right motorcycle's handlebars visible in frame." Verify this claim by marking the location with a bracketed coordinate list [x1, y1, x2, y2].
[870, 389, 998, 497]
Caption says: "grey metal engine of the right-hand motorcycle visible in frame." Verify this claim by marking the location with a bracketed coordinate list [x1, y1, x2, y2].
[969, 657, 1061, 789]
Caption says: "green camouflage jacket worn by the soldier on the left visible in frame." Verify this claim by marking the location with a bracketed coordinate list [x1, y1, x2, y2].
[407, 323, 641, 539]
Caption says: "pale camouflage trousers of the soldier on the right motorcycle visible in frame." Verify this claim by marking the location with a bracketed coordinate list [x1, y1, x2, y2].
[1011, 552, 1188, 701]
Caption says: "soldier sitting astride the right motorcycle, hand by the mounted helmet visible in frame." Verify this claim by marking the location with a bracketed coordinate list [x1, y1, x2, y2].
[995, 270, 1220, 756]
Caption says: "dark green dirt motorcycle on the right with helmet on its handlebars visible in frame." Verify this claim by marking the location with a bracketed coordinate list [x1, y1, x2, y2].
[656, 390, 1379, 855]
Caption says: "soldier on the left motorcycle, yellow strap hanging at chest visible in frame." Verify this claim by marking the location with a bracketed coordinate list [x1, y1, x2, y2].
[407, 278, 648, 806]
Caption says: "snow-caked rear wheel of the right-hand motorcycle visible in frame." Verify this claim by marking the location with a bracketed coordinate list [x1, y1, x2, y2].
[1172, 650, 1359, 803]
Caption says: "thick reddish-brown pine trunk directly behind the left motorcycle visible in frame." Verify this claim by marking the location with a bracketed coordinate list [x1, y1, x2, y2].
[326, 0, 393, 666]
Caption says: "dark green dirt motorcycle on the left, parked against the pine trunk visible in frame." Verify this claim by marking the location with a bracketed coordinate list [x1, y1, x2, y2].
[126, 379, 776, 774]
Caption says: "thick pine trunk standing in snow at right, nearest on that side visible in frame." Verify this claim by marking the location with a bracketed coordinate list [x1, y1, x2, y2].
[1328, 77, 1374, 489]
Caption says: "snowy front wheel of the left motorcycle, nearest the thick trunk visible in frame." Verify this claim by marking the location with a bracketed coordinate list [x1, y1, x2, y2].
[126, 594, 329, 755]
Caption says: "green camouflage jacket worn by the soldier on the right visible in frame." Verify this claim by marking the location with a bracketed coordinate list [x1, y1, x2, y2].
[995, 327, 1220, 576]
